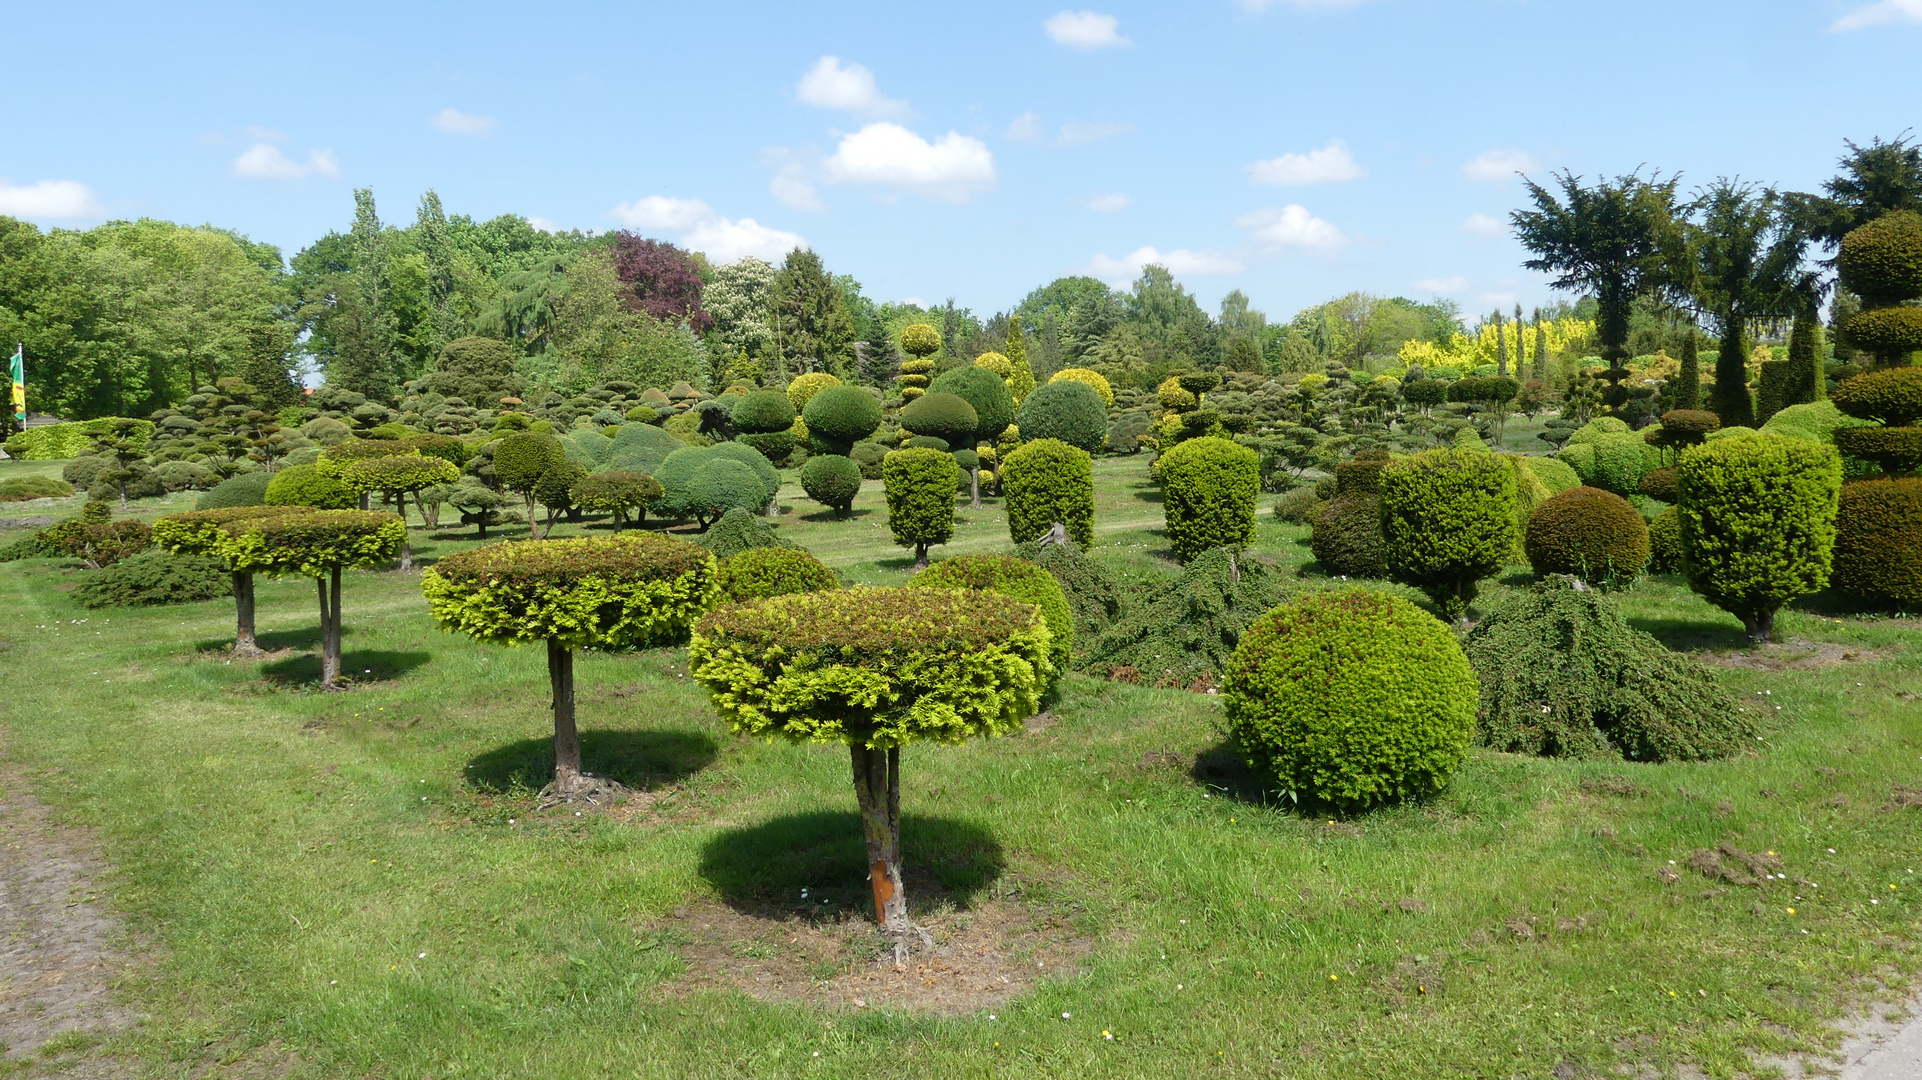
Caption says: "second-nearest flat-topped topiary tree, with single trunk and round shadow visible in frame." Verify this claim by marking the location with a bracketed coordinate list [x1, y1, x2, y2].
[421, 534, 721, 801]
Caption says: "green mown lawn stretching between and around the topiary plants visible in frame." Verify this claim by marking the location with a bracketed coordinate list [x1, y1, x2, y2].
[0, 455, 1922, 1078]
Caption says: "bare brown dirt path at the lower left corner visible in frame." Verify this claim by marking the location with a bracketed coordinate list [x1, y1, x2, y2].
[0, 765, 138, 1076]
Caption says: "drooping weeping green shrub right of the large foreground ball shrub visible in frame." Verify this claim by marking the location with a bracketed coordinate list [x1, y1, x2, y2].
[1466, 575, 1755, 761]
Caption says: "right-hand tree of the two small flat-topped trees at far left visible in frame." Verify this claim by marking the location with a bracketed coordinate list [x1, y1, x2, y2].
[219, 509, 407, 690]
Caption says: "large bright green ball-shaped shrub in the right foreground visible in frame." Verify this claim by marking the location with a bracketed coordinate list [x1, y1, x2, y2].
[1222, 590, 1478, 811]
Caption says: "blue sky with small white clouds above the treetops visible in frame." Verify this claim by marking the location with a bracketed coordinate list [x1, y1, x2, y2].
[0, 0, 1922, 317]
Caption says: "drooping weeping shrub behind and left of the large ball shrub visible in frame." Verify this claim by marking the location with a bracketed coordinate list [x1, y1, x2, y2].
[1080, 548, 1290, 688]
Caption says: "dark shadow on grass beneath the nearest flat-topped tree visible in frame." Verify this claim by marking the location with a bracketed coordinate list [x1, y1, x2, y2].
[702, 811, 1007, 915]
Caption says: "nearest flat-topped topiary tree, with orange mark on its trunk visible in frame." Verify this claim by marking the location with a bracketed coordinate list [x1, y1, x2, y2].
[688, 584, 1053, 930]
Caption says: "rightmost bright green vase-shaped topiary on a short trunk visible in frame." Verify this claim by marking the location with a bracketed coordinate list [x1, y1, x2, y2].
[1676, 434, 1841, 642]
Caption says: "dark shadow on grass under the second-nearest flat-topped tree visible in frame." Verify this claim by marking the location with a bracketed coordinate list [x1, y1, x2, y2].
[467, 728, 721, 794]
